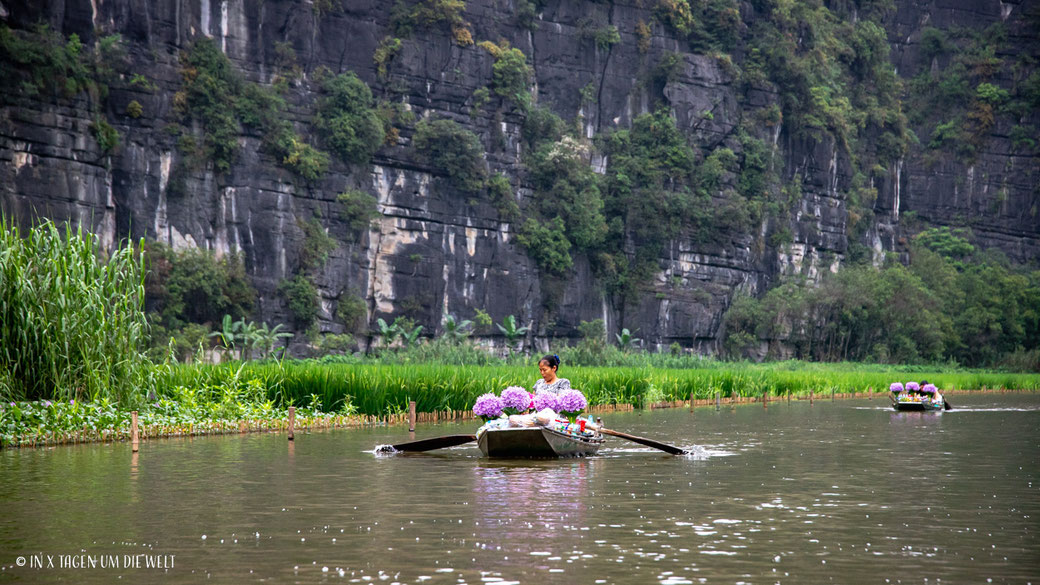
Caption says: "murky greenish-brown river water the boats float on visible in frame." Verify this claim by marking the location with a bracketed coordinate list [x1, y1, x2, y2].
[0, 395, 1040, 584]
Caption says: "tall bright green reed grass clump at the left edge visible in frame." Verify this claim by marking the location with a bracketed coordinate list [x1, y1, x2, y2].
[0, 217, 154, 403]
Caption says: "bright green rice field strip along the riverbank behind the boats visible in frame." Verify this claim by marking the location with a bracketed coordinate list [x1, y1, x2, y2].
[166, 362, 1040, 415]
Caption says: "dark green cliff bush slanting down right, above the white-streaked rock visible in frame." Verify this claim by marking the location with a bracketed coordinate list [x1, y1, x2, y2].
[412, 119, 487, 193]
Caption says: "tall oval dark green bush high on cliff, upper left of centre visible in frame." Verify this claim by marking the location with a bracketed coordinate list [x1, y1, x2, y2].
[314, 72, 385, 163]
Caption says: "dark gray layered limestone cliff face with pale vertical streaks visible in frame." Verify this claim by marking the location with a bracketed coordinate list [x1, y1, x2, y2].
[0, 0, 1040, 353]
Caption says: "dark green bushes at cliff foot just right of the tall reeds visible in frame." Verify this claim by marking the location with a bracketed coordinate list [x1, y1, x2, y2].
[145, 243, 256, 331]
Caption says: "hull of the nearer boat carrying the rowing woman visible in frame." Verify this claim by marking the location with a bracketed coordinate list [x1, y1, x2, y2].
[476, 427, 603, 457]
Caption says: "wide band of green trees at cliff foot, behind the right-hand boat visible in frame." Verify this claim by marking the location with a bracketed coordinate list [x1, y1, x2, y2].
[724, 241, 1040, 365]
